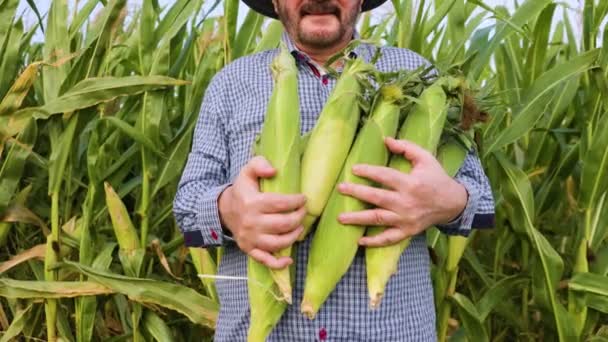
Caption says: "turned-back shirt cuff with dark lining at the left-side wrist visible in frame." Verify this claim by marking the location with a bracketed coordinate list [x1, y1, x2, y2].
[184, 183, 234, 247]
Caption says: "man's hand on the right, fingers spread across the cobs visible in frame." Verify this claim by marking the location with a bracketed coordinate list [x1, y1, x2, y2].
[338, 138, 468, 246]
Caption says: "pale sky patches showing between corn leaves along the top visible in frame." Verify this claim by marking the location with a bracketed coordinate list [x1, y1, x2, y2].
[18, 0, 588, 41]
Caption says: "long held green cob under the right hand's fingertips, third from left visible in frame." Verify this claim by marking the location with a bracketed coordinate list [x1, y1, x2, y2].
[301, 85, 402, 319]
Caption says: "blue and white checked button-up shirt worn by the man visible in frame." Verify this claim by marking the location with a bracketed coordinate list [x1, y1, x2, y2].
[174, 34, 494, 342]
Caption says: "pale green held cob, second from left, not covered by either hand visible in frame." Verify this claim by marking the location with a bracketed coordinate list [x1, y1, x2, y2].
[298, 59, 373, 241]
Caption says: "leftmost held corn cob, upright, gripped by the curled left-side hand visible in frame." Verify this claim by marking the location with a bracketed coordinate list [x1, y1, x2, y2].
[248, 46, 301, 341]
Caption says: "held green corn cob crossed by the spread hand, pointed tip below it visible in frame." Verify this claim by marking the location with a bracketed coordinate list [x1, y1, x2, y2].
[365, 78, 449, 308]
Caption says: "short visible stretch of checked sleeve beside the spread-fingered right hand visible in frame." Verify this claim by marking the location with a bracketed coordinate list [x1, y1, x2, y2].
[437, 149, 494, 236]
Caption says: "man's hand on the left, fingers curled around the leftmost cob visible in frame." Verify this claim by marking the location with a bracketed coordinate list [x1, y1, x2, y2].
[218, 157, 306, 269]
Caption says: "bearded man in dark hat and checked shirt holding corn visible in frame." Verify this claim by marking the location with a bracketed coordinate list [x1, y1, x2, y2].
[174, 0, 494, 341]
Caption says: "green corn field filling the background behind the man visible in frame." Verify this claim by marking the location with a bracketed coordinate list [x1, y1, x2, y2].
[0, 0, 608, 342]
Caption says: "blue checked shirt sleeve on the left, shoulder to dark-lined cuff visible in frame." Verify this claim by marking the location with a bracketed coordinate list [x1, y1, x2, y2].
[173, 74, 232, 247]
